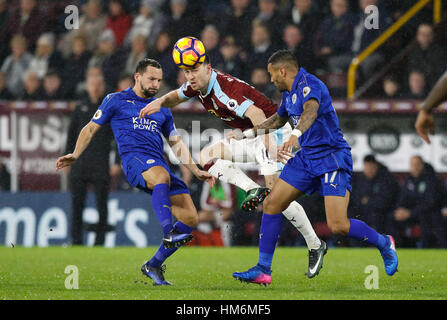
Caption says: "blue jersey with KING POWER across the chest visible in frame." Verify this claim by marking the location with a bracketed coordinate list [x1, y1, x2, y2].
[92, 88, 178, 160]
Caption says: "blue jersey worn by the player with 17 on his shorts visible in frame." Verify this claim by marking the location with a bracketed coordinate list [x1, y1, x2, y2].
[277, 68, 351, 159]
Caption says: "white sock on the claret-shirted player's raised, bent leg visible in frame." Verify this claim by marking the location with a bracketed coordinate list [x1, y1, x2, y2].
[208, 159, 261, 192]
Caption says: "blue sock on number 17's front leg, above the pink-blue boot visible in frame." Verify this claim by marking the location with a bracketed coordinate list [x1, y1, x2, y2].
[258, 213, 282, 272]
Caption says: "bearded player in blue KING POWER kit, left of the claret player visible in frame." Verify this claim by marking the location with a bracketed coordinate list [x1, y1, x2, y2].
[56, 59, 214, 285]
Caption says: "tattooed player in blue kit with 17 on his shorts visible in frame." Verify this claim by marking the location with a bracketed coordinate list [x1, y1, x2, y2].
[233, 50, 398, 285]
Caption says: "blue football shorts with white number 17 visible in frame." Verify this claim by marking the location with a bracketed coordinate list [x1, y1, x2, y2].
[279, 149, 352, 197]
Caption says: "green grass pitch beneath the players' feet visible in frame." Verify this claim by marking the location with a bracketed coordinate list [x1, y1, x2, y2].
[0, 247, 447, 300]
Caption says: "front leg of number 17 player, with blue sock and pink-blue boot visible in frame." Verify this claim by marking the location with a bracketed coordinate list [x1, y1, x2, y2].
[233, 179, 303, 285]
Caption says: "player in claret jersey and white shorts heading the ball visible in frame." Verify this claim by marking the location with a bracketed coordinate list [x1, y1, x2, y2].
[140, 57, 327, 278]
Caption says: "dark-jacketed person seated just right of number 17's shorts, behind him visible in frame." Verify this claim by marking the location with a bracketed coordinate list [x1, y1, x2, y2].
[349, 155, 399, 233]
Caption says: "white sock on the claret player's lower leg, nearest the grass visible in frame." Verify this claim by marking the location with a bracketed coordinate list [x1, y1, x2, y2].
[282, 201, 321, 250]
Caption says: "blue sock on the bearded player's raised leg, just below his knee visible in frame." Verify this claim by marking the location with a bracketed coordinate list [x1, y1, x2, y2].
[152, 183, 172, 235]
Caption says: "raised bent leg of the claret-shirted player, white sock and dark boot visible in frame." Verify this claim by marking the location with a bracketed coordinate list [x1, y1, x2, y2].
[200, 139, 270, 210]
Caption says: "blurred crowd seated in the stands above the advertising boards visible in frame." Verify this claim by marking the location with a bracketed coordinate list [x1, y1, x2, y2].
[0, 0, 446, 100]
